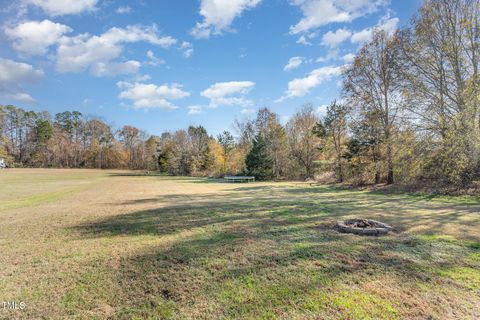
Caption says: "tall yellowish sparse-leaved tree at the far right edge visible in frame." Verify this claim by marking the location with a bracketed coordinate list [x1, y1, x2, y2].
[400, 0, 480, 184]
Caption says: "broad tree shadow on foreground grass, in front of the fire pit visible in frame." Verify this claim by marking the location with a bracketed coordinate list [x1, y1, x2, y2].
[93, 222, 478, 318]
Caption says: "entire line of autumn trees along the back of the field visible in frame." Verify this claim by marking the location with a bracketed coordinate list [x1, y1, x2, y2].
[0, 0, 480, 186]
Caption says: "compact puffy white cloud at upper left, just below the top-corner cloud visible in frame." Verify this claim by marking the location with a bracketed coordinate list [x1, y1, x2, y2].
[5, 20, 72, 55]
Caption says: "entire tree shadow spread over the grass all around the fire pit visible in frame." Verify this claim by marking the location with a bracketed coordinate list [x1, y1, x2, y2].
[67, 186, 480, 318]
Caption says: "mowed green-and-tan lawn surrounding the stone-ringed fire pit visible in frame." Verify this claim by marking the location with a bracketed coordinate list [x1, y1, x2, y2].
[0, 169, 480, 319]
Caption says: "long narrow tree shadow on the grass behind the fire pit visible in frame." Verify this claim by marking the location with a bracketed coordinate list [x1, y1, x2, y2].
[74, 182, 480, 237]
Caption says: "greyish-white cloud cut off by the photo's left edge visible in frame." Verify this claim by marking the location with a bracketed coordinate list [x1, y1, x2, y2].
[0, 58, 44, 103]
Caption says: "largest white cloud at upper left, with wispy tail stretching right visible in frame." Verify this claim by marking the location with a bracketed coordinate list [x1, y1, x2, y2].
[56, 25, 176, 76]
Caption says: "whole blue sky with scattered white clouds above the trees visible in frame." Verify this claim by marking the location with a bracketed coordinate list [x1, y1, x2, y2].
[0, 0, 421, 134]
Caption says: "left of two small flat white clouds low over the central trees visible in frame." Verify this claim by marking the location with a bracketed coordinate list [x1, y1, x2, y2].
[117, 81, 190, 109]
